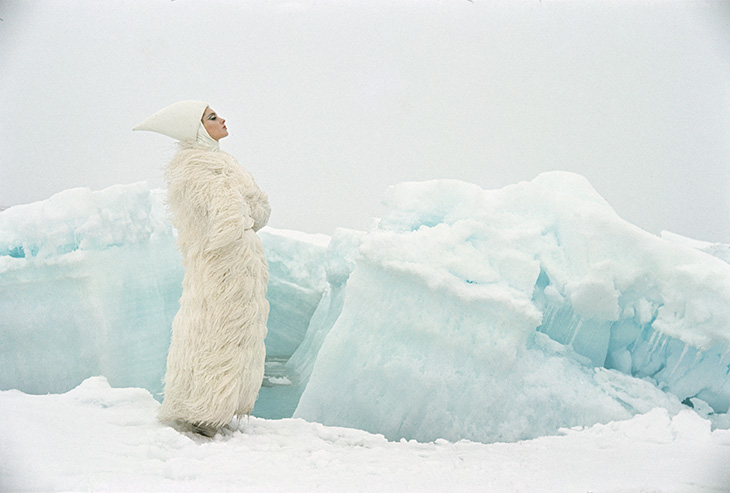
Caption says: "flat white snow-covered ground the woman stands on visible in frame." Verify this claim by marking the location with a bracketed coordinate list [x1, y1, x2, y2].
[0, 378, 730, 493]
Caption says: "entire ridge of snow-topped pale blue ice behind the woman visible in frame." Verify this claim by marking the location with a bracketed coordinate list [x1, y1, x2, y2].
[0, 172, 730, 442]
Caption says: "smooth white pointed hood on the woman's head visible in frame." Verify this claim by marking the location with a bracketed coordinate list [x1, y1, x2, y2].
[132, 101, 218, 150]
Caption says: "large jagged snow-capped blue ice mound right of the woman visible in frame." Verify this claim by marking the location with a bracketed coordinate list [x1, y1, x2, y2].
[295, 172, 730, 441]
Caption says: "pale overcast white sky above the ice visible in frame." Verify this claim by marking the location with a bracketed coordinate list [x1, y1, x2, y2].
[0, 0, 730, 243]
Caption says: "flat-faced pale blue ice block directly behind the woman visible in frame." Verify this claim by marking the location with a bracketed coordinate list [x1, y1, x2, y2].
[0, 183, 329, 408]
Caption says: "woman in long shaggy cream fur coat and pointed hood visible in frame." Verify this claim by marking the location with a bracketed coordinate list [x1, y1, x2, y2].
[134, 101, 271, 436]
